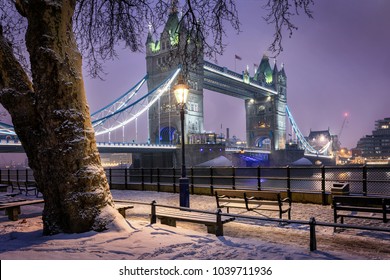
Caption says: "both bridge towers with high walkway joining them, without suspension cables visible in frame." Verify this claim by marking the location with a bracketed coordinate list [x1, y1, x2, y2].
[146, 9, 287, 151]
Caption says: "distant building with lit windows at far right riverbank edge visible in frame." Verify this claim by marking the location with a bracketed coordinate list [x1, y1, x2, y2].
[356, 118, 390, 163]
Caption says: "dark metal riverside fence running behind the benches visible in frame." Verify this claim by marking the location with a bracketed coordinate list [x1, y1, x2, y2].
[0, 165, 390, 200]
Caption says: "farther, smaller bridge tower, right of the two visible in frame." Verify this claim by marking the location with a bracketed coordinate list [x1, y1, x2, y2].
[245, 55, 287, 151]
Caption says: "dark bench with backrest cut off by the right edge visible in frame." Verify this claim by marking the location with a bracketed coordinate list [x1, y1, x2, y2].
[332, 195, 390, 229]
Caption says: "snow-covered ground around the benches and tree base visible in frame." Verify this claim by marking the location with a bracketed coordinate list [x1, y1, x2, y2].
[0, 190, 390, 260]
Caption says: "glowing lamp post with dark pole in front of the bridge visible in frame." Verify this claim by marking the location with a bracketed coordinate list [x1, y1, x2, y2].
[173, 74, 190, 207]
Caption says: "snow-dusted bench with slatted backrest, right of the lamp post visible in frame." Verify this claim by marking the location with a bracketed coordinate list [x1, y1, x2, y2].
[214, 189, 291, 219]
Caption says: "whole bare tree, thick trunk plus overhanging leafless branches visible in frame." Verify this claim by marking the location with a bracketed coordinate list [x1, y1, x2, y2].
[0, 0, 311, 234]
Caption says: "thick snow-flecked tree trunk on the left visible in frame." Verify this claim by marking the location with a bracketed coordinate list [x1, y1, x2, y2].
[0, 0, 124, 234]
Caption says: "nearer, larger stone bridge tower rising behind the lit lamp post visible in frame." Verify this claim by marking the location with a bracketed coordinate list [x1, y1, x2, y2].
[146, 4, 204, 144]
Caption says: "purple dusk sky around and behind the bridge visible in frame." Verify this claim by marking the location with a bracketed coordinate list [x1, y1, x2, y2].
[86, 0, 390, 148]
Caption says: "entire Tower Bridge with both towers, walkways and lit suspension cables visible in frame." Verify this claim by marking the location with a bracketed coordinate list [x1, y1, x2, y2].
[0, 6, 336, 166]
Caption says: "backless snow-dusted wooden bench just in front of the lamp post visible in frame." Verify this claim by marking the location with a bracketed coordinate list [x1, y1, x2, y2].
[151, 207, 234, 236]
